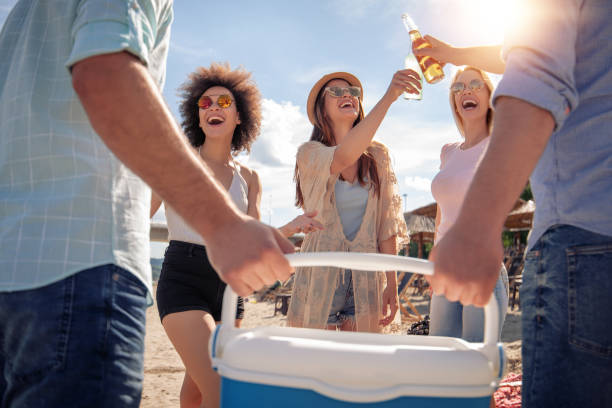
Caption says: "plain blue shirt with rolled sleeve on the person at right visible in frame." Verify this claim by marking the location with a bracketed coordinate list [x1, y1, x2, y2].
[493, 0, 612, 247]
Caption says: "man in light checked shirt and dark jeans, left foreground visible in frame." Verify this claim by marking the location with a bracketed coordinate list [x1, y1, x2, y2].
[0, 0, 293, 407]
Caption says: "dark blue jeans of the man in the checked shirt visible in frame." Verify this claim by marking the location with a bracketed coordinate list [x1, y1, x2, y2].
[0, 265, 147, 408]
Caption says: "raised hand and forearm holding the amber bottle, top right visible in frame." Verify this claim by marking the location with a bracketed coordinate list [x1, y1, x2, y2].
[414, 35, 506, 74]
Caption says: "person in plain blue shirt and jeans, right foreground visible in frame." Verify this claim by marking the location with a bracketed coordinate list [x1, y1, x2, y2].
[430, 0, 612, 408]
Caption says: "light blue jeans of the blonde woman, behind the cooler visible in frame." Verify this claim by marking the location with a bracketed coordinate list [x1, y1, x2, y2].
[429, 266, 508, 342]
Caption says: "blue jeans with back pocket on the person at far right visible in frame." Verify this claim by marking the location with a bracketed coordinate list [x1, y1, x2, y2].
[521, 225, 612, 408]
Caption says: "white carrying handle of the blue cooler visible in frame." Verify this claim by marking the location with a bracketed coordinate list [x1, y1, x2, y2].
[217, 252, 500, 370]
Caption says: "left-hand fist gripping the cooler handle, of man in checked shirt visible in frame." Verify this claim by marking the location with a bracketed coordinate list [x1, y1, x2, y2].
[206, 215, 294, 296]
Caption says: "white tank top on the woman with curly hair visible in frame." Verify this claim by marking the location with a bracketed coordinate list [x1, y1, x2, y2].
[164, 159, 249, 245]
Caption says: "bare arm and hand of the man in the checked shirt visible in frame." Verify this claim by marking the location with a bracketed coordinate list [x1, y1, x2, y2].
[72, 52, 293, 295]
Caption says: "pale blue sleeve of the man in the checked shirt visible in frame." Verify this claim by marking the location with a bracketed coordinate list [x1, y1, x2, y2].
[66, 0, 157, 68]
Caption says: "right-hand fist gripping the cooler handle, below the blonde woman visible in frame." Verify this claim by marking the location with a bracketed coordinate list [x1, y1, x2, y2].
[426, 224, 503, 307]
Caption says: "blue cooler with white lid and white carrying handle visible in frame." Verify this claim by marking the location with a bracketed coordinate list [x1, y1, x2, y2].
[209, 252, 504, 408]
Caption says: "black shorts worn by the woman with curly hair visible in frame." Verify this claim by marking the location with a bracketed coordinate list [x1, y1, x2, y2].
[156, 241, 244, 322]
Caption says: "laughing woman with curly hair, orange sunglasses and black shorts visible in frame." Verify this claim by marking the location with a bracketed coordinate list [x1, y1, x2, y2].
[151, 64, 322, 407]
